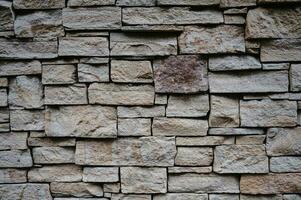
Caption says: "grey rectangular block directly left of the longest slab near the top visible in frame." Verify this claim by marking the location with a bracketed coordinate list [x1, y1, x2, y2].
[63, 7, 121, 30]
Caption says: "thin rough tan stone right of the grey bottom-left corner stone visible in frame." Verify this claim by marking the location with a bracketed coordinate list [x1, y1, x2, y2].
[50, 182, 103, 197]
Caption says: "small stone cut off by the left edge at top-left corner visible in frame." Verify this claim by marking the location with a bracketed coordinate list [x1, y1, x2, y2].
[0, 1, 14, 31]
